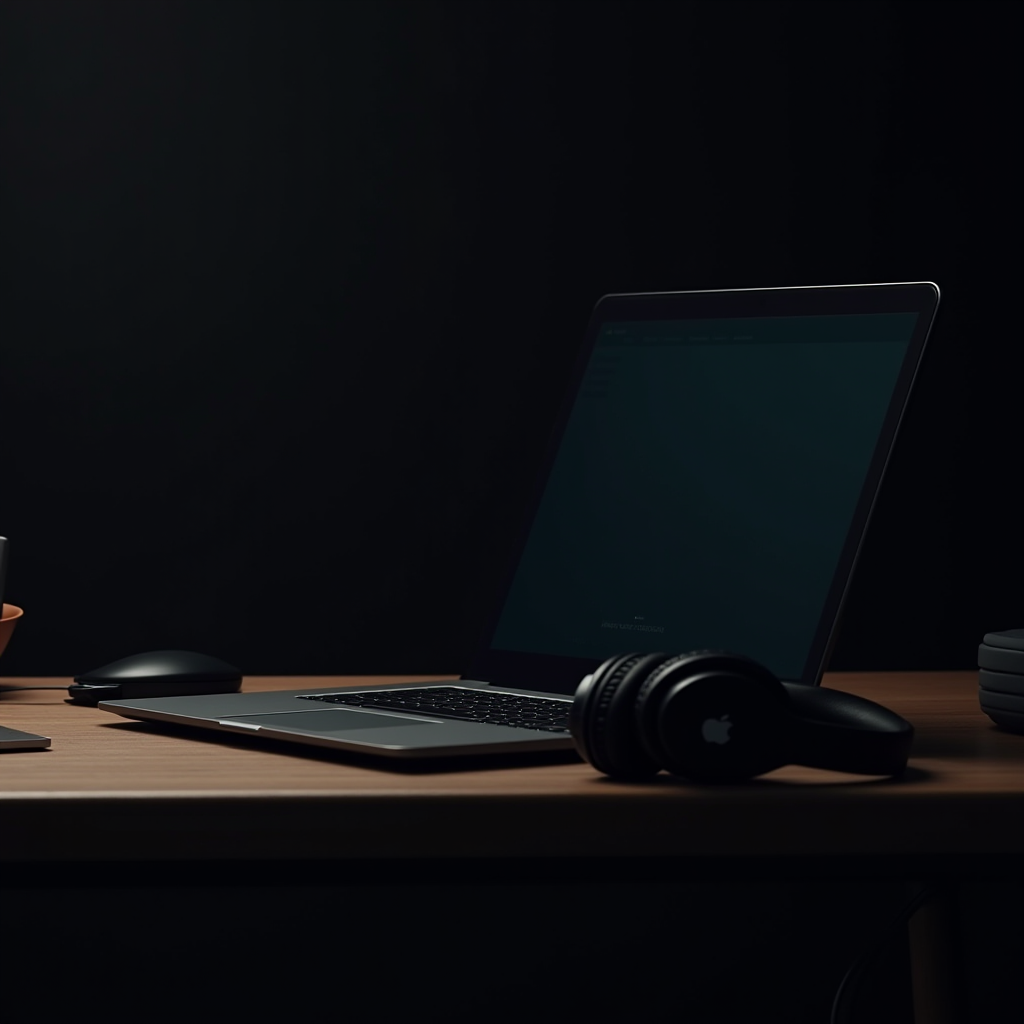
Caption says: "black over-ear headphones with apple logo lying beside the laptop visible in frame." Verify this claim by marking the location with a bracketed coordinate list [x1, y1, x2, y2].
[569, 650, 913, 782]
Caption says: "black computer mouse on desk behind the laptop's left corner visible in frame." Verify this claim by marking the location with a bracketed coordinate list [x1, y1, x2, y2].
[68, 650, 242, 706]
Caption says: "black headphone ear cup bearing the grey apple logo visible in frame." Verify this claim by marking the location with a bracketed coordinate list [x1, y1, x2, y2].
[634, 651, 793, 782]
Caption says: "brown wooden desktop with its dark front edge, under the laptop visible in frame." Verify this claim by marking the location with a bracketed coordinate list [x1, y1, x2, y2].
[0, 672, 1024, 861]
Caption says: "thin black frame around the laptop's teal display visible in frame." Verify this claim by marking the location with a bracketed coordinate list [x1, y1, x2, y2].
[463, 282, 939, 694]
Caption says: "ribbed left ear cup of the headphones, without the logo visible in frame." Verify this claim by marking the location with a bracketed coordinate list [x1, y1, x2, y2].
[569, 653, 669, 779]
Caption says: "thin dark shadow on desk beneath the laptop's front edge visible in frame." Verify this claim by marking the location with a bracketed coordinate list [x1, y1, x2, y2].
[101, 722, 581, 775]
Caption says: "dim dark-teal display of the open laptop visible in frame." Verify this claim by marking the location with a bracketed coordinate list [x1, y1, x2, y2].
[468, 284, 937, 688]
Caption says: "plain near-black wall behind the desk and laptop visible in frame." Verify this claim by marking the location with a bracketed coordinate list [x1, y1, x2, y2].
[0, 0, 1024, 675]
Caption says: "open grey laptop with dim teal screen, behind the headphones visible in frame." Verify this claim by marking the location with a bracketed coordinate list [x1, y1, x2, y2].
[99, 283, 939, 760]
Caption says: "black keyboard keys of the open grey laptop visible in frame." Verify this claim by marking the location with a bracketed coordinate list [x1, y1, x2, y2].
[301, 686, 572, 732]
